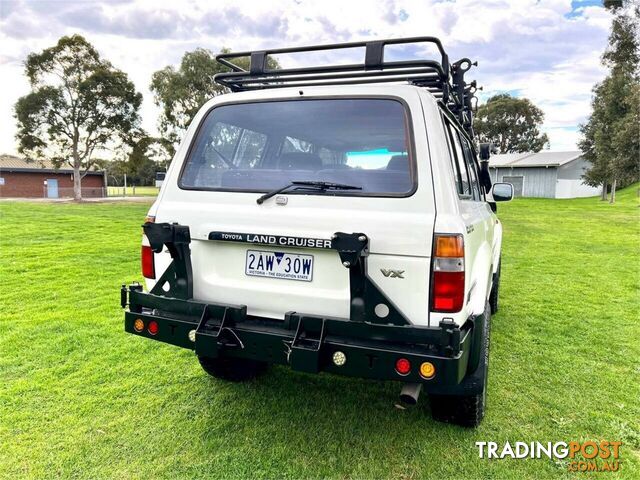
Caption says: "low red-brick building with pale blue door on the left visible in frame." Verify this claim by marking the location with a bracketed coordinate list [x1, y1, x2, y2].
[0, 155, 106, 198]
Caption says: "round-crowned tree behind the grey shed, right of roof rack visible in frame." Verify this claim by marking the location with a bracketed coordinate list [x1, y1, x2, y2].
[473, 93, 549, 153]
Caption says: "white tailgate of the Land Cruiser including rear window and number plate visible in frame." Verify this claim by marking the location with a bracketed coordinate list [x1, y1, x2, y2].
[156, 87, 434, 324]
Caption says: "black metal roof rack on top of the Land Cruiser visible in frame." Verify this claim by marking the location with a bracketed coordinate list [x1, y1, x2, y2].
[214, 37, 477, 136]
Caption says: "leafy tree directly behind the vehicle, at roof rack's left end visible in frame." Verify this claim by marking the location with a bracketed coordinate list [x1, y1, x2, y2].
[150, 48, 279, 155]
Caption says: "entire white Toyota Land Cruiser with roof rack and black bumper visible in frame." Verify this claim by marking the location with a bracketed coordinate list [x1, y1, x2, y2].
[121, 37, 512, 426]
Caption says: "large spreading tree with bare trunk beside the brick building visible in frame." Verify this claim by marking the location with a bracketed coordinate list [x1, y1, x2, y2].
[15, 35, 142, 200]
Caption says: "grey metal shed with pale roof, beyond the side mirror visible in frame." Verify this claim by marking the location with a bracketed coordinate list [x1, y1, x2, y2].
[489, 151, 600, 198]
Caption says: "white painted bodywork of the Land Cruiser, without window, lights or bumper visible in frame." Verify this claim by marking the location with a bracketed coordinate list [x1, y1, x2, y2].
[143, 85, 502, 326]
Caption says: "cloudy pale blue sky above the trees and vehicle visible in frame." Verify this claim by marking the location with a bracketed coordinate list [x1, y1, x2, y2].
[0, 0, 611, 154]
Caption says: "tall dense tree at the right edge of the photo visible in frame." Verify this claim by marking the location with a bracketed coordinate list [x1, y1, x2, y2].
[578, 2, 640, 203]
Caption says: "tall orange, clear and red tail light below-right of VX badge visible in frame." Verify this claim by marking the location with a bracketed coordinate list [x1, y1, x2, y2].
[431, 235, 464, 313]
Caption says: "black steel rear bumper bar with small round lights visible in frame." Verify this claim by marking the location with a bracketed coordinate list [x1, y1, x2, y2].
[122, 285, 471, 386]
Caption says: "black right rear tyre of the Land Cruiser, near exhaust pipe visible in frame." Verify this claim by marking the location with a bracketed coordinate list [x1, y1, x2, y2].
[429, 303, 491, 427]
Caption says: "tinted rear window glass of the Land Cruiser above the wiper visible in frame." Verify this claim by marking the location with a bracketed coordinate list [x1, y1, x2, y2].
[180, 99, 414, 195]
